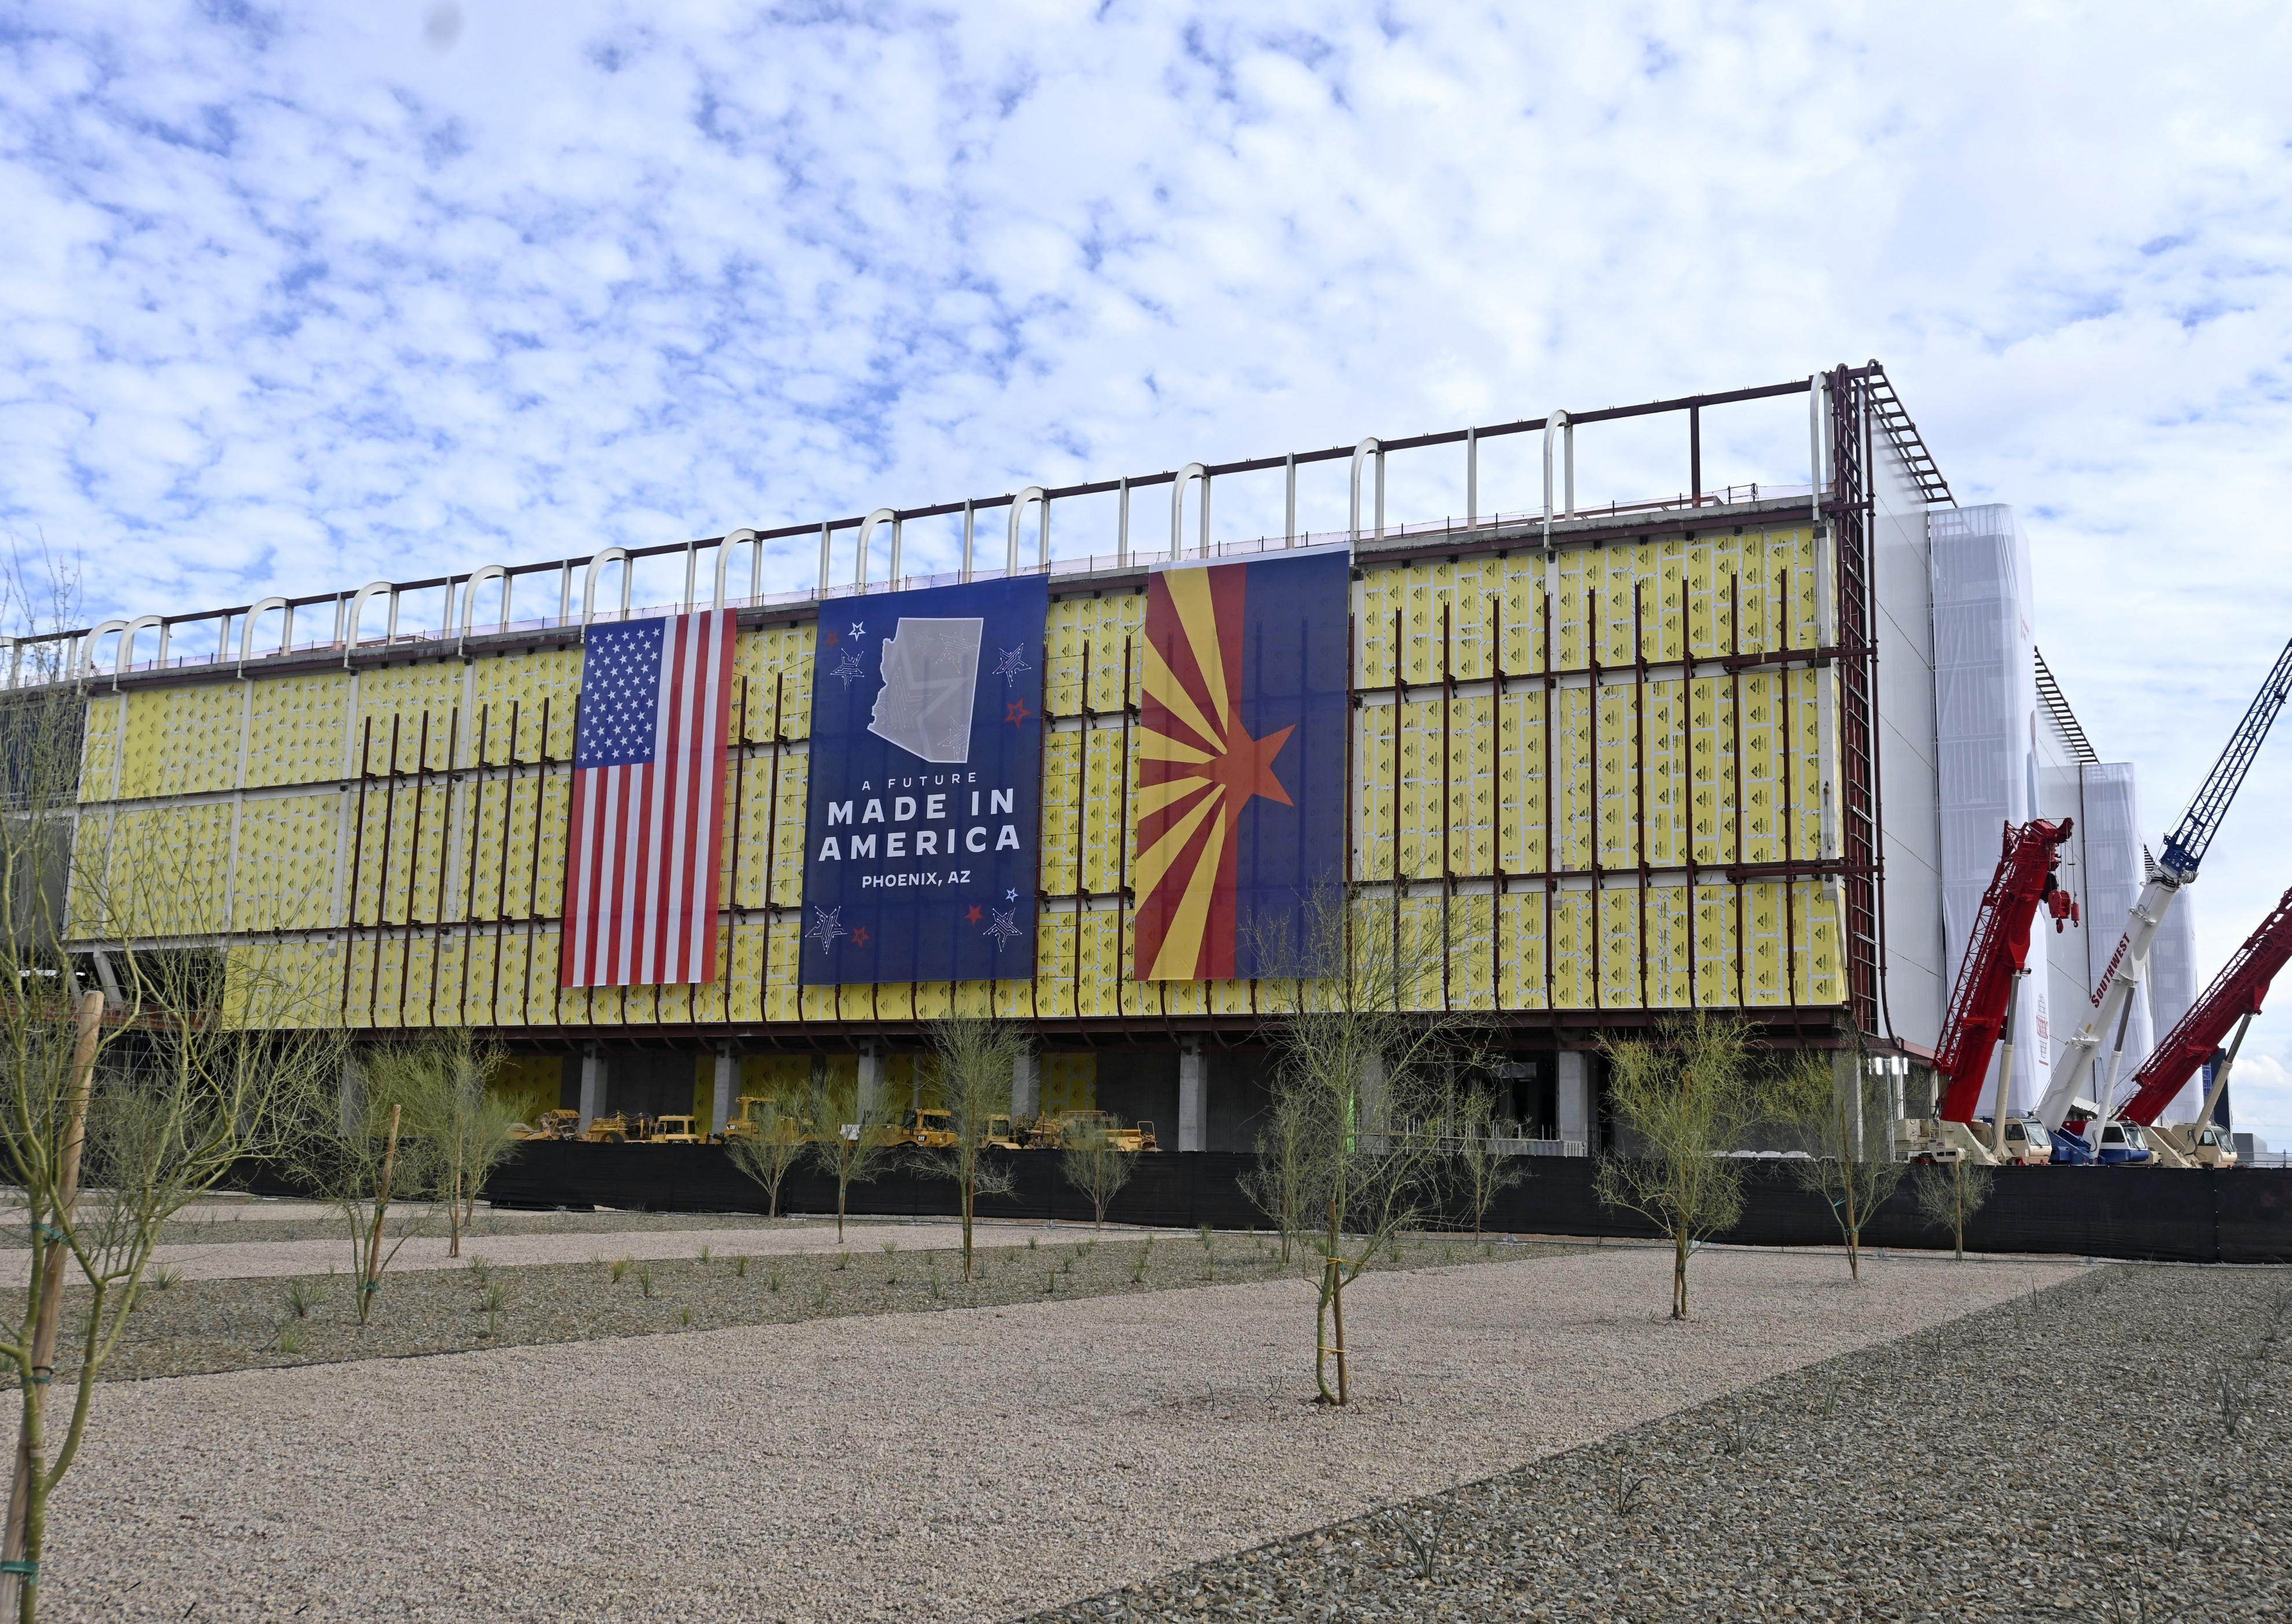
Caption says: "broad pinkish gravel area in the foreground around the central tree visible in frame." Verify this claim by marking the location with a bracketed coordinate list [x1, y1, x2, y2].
[9, 1248, 2091, 1624]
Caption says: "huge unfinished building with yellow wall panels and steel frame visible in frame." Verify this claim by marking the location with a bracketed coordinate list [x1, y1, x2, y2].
[27, 364, 2194, 1152]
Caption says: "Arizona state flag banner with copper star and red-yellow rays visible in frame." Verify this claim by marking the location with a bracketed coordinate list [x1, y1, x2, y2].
[1132, 548, 1352, 980]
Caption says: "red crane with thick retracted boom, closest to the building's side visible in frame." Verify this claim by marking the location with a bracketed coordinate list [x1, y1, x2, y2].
[1896, 818, 2077, 1166]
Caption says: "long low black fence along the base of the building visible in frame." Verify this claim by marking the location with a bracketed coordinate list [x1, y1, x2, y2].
[465, 1143, 2292, 1265]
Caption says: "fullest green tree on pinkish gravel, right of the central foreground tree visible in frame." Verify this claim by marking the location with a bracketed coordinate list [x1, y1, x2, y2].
[1593, 1010, 1762, 1320]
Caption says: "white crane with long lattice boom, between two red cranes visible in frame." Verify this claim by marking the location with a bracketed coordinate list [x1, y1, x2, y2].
[2037, 641, 2292, 1159]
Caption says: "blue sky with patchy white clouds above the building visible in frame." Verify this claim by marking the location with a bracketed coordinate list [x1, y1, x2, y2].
[13, 0, 2292, 1141]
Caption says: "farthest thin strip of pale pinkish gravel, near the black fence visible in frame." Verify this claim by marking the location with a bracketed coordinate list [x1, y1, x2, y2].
[0, 1214, 1171, 1289]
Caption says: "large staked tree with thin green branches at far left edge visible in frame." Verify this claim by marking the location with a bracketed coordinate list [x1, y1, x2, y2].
[0, 570, 339, 1619]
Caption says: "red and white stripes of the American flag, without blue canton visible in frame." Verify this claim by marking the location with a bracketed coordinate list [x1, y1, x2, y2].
[559, 609, 736, 987]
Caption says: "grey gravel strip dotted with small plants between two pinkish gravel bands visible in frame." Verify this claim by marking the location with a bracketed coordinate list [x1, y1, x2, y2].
[40, 1223, 1524, 1386]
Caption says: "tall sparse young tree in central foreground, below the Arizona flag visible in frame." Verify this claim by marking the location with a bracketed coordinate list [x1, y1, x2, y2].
[1254, 891, 1464, 1404]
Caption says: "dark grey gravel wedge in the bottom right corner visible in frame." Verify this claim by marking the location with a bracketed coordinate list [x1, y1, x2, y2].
[1036, 1267, 2292, 1624]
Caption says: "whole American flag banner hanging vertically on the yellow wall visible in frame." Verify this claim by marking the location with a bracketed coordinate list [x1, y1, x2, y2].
[557, 609, 736, 987]
